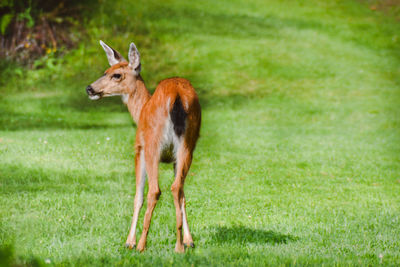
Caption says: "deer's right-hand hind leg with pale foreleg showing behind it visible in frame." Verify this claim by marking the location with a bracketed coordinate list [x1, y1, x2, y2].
[171, 144, 194, 252]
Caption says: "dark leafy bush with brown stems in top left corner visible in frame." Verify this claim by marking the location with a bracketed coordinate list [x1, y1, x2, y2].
[0, 0, 96, 63]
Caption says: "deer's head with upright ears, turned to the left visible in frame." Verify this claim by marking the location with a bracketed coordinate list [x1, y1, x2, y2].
[86, 41, 140, 100]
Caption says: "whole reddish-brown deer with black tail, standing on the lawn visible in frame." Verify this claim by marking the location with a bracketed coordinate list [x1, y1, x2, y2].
[86, 40, 201, 253]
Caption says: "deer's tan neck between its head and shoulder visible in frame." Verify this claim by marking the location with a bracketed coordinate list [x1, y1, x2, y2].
[122, 75, 151, 124]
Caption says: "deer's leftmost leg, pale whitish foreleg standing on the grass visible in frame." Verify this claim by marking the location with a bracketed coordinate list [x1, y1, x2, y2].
[125, 149, 146, 249]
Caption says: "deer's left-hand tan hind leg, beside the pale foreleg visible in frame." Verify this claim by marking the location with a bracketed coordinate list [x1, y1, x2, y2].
[137, 153, 161, 252]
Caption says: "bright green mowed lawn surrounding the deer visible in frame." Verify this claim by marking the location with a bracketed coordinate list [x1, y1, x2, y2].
[0, 0, 400, 266]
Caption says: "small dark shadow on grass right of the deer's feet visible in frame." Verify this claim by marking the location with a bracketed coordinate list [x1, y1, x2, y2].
[211, 226, 298, 245]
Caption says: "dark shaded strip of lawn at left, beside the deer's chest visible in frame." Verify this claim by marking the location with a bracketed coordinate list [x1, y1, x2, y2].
[0, 94, 136, 131]
